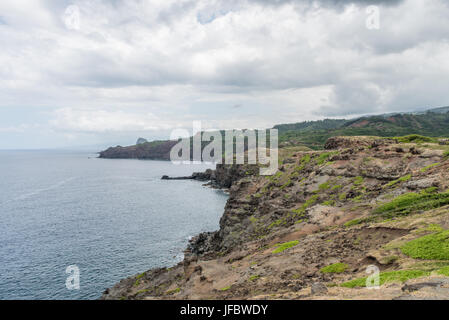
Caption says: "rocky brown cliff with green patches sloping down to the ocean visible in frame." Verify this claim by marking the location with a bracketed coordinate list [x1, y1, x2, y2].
[103, 137, 449, 299]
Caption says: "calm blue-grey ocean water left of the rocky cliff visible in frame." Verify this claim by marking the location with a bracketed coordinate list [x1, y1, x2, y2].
[0, 151, 227, 299]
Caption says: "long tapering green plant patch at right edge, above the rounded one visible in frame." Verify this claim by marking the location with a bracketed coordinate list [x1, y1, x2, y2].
[374, 191, 449, 217]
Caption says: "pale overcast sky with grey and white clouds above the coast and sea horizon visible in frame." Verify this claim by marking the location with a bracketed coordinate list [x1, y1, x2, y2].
[0, 0, 449, 149]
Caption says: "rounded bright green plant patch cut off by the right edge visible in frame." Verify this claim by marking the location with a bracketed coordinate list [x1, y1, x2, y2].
[401, 230, 449, 260]
